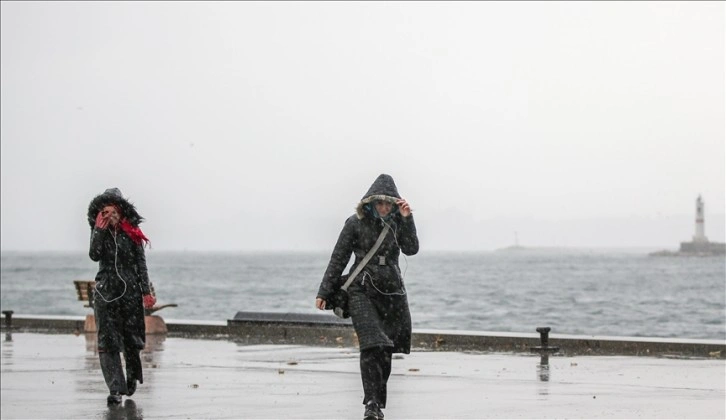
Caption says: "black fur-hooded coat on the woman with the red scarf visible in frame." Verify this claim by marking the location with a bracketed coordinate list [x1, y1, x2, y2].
[88, 188, 151, 360]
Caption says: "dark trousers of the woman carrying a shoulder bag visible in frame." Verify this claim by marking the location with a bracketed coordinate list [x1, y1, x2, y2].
[360, 347, 393, 408]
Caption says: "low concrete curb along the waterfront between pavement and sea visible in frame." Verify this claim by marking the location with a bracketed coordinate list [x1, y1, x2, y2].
[2, 313, 726, 359]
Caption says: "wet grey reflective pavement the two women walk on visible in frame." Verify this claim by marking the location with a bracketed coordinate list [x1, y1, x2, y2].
[0, 332, 726, 420]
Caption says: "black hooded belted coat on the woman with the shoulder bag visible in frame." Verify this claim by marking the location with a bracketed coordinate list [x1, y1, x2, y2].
[318, 174, 419, 353]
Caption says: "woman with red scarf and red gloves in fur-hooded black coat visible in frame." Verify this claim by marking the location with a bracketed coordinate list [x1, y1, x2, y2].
[88, 188, 156, 404]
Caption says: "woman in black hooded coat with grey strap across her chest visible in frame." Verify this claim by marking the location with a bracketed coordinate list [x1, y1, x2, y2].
[315, 174, 418, 420]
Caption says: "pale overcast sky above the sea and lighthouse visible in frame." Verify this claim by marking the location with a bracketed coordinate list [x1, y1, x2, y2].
[0, 2, 726, 251]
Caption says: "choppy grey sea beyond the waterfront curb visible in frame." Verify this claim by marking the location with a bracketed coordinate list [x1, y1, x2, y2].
[0, 249, 726, 340]
